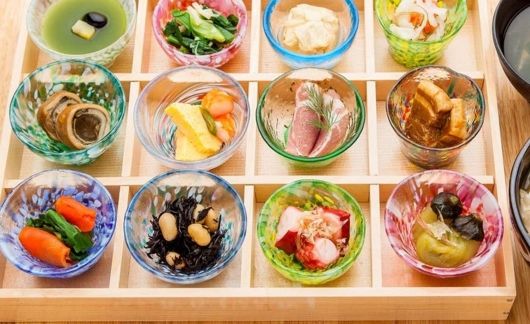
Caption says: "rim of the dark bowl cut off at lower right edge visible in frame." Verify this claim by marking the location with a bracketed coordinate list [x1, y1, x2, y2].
[508, 138, 530, 249]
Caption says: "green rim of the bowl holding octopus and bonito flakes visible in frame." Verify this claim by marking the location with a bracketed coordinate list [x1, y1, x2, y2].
[256, 179, 366, 280]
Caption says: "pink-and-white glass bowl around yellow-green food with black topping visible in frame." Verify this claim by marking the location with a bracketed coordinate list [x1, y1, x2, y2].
[384, 170, 504, 278]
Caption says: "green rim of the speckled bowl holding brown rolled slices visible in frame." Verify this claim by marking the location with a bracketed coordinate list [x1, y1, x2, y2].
[9, 59, 127, 158]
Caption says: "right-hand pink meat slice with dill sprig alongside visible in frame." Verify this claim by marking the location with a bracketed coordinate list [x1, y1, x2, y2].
[309, 90, 350, 157]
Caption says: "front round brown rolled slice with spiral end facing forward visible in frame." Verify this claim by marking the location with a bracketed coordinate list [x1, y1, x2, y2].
[56, 103, 110, 150]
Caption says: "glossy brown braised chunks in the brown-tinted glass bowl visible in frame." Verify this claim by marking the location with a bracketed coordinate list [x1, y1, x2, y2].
[405, 81, 467, 148]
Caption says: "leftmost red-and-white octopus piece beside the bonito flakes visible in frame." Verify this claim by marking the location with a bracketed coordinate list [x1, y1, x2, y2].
[275, 206, 303, 254]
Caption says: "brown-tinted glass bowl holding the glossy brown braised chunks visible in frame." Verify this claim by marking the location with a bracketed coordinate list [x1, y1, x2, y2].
[386, 66, 486, 169]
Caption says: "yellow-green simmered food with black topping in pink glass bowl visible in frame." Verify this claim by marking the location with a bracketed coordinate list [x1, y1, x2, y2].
[412, 192, 484, 268]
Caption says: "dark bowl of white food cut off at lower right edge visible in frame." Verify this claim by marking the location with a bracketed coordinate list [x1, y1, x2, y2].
[509, 139, 530, 263]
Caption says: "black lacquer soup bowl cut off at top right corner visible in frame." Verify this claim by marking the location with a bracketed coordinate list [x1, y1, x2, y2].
[493, 0, 530, 102]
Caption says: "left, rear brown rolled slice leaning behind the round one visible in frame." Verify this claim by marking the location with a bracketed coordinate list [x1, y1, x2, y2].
[37, 91, 81, 141]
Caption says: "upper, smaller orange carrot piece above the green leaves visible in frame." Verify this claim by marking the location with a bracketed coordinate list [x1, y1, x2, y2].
[55, 196, 97, 233]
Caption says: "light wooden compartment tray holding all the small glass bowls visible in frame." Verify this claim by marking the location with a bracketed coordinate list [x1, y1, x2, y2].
[0, 0, 515, 321]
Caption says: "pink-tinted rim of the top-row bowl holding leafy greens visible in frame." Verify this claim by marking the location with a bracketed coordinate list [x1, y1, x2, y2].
[151, 0, 248, 61]
